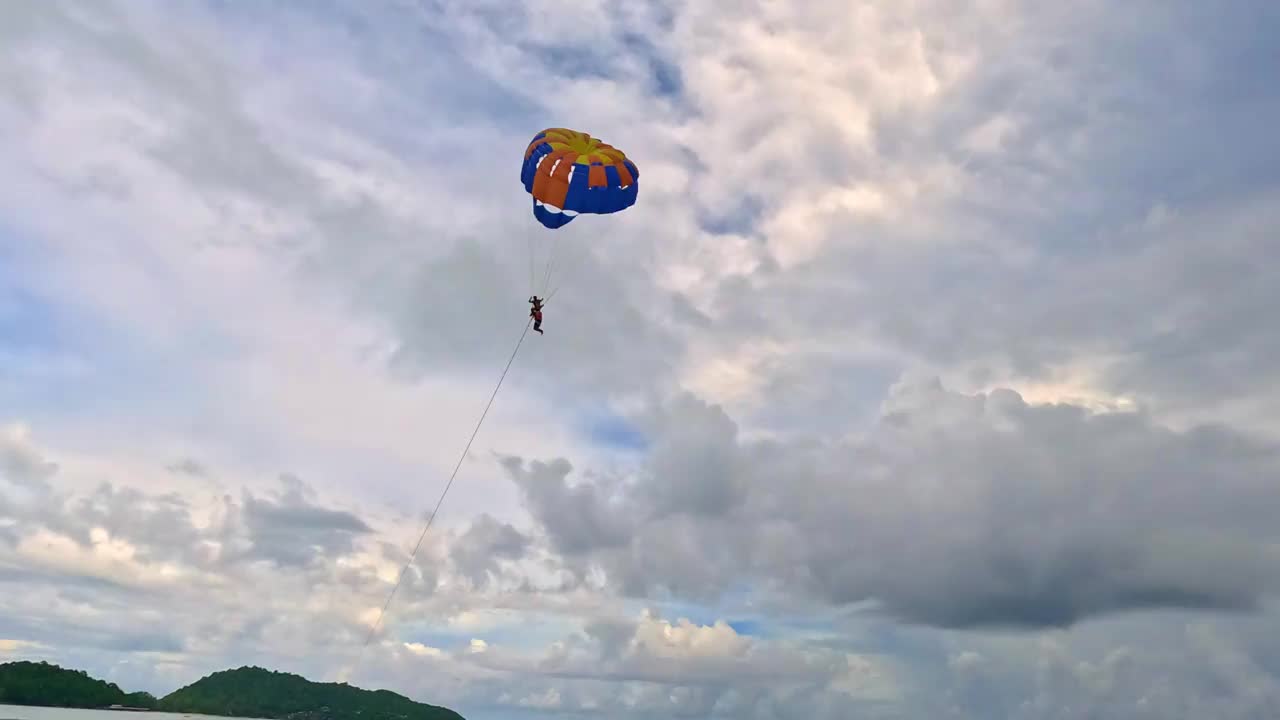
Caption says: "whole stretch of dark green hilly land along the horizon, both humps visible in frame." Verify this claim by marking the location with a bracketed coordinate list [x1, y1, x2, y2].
[0, 661, 463, 720]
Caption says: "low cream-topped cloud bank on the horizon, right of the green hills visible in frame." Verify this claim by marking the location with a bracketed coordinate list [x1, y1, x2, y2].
[399, 611, 892, 717]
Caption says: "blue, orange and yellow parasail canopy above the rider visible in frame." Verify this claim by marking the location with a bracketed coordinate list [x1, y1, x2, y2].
[520, 128, 640, 229]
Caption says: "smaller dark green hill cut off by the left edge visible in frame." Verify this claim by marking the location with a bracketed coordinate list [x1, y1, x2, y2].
[0, 662, 156, 708]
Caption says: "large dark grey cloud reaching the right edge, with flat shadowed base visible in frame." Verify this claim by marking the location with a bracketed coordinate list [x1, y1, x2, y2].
[508, 383, 1280, 628]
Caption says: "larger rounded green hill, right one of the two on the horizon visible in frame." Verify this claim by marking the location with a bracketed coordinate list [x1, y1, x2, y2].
[157, 667, 462, 720]
